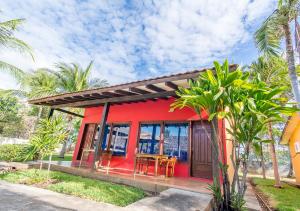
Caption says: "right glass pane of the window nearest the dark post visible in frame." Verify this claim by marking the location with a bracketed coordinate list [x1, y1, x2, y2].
[110, 125, 129, 155]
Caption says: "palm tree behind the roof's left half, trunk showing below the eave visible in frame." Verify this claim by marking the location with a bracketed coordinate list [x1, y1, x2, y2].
[48, 61, 108, 158]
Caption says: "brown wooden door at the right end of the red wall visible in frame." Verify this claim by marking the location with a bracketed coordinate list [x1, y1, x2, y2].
[191, 122, 212, 179]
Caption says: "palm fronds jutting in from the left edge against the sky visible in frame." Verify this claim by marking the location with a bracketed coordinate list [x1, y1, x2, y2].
[0, 19, 34, 77]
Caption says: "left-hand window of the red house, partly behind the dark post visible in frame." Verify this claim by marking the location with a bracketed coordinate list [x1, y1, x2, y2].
[102, 124, 129, 156]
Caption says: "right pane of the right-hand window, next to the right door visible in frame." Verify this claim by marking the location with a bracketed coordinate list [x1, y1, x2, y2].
[163, 123, 188, 161]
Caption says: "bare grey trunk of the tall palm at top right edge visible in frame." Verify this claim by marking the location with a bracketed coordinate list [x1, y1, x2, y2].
[283, 23, 300, 104]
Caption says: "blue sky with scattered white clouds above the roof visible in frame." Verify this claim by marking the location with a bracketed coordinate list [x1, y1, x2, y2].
[0, 0, 276, 89]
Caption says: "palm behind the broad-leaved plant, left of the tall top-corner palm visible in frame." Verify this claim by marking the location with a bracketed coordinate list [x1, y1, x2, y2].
[250, 56, 290, 187]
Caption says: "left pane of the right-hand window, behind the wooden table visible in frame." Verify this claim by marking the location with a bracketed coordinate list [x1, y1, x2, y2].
[139, 124, 160, 154]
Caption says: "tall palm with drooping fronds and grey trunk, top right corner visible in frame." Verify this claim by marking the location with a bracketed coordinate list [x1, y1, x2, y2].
[255, 0, 300, 107]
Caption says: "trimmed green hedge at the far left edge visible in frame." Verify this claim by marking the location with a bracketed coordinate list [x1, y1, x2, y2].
[0, 144, 28, 162]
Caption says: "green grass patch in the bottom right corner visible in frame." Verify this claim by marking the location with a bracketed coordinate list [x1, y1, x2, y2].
[253, 178, 300, 211]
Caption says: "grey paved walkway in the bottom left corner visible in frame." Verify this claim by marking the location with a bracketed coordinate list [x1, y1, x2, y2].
[0, 180, 119, 211]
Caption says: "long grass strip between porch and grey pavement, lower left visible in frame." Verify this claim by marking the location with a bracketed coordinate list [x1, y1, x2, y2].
[0, 169, 145, 206]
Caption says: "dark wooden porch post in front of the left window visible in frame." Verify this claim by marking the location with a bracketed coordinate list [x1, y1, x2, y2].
[92, 103, 110, 169]
